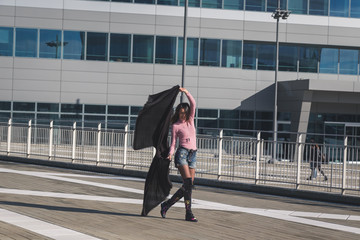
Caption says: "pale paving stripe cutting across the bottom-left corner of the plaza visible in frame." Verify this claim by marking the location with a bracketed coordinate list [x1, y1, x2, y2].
[0, 208, 100, 240]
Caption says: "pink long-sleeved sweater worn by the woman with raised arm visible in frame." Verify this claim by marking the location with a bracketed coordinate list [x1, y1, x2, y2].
[169, 92, 197, 155]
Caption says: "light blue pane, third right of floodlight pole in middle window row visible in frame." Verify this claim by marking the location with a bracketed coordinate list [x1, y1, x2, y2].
[319, 48, 339, 73]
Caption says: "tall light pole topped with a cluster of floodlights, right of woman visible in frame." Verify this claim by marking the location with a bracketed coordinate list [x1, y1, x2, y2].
[271, 0, 290, 162]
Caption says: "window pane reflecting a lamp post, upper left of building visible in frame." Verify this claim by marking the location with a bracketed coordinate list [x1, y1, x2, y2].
[39, 29, 62, 58]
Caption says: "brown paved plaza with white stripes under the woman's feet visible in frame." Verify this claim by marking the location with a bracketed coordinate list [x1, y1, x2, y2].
[0, 161, 360, 240]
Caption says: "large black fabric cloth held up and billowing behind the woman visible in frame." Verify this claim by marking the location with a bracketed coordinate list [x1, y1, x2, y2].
[133, 85, 179, 216]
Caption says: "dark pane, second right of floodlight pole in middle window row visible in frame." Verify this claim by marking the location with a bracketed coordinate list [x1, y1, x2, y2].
[299, 47, 319, 73]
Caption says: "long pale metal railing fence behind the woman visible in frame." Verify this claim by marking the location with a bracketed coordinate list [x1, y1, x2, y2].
[0, 119, 360, 195]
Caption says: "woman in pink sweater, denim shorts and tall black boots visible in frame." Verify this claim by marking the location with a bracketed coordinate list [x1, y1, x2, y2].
[160, 88, 197, 222]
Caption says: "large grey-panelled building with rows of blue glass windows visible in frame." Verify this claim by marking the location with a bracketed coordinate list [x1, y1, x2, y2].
[0, 0, 360, 144]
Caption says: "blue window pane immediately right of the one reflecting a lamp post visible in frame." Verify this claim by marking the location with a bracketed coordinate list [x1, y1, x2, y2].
[63, 31, 85, 60]
